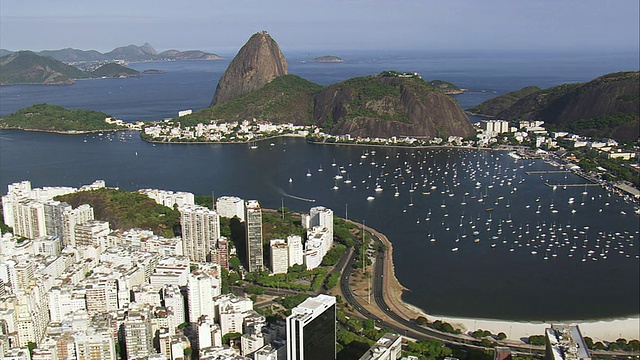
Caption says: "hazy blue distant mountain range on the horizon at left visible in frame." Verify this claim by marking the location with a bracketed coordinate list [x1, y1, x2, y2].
[0, 43, 224, 64]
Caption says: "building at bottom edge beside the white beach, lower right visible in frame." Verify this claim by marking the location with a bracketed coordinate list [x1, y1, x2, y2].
[544, 325, 591, 360]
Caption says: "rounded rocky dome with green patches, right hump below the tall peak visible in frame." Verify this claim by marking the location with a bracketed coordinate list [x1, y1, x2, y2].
[313, 74, 476, 138]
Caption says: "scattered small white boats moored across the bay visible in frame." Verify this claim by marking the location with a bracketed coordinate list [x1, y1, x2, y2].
[300, 149, 639, 262]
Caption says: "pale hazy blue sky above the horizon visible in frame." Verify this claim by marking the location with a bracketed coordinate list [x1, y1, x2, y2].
[0, 0, 640, 53]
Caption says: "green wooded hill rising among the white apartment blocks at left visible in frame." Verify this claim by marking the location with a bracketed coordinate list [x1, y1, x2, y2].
[55, 188, 180, 237]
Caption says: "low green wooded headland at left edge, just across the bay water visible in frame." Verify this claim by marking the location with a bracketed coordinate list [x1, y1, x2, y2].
[0, 104, 123, 131]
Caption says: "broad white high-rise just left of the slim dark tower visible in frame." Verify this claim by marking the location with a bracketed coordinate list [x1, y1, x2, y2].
[179, 205, 220, 262]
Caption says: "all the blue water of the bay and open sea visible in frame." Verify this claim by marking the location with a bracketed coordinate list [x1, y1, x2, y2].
[0, 50, 640, 320]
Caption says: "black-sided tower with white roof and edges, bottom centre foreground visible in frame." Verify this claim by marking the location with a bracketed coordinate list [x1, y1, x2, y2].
[287, 294, 336, 360]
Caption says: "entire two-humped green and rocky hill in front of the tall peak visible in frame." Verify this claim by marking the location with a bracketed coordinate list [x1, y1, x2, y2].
[172, 71, 474, 137]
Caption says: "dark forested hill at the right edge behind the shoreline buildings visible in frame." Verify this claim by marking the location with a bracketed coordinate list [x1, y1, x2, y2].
[468, 71, 640, 141]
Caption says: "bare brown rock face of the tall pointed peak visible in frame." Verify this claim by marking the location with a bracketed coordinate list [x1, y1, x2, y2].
[211, 31, 288, 106]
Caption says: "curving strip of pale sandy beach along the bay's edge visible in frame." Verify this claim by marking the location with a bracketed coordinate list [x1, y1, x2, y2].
[365, 221, 640, 342]
